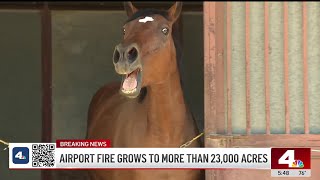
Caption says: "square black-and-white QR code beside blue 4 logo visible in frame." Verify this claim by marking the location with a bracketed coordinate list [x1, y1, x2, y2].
[32, 144, 55, 168]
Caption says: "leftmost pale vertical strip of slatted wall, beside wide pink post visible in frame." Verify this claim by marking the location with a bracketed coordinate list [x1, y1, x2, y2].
[228, 2, 246, 134]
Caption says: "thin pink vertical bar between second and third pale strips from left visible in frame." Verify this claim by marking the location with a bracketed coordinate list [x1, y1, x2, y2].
[264, 2, 270, 134]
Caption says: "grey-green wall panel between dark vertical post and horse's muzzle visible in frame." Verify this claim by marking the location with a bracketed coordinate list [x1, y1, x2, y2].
[52, 11, 125, 140]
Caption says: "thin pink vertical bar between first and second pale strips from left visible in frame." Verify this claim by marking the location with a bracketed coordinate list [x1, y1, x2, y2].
[246, 2, 251, 134]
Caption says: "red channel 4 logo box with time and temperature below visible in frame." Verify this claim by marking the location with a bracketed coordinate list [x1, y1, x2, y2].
[271, 148, 311, 177]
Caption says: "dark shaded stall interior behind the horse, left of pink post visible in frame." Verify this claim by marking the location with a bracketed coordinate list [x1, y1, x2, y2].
[0, 2, 204, 180]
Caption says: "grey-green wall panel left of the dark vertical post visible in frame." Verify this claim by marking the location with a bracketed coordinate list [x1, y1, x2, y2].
[0, 10, 41, 180]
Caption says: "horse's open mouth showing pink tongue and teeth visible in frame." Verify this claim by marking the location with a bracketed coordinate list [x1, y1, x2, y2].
[121, 68, 142, 98]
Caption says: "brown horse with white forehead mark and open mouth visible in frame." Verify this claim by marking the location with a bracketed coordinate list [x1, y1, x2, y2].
[87, 2, 203, 180]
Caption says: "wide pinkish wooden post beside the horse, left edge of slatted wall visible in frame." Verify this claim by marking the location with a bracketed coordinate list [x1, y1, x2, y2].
[203, 2, 227, 134]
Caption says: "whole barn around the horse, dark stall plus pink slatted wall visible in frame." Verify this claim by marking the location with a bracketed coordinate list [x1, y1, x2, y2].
[0, 2, 320, 180]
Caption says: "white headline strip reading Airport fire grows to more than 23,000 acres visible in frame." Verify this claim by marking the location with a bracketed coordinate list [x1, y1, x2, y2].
[9, 143, 271, 169]
